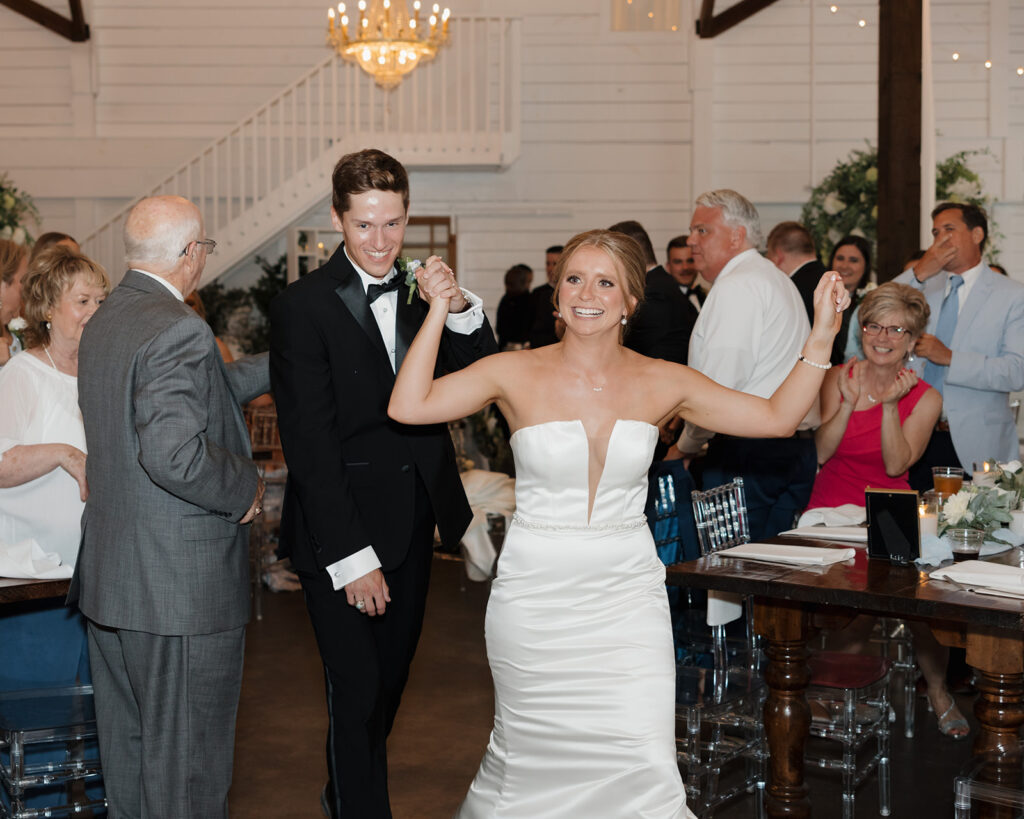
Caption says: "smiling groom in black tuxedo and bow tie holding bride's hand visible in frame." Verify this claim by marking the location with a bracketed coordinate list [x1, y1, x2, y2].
[270, 149, 497, 819]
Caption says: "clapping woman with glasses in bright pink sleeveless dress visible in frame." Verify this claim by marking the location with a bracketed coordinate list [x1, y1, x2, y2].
[808, 282, 969, 739]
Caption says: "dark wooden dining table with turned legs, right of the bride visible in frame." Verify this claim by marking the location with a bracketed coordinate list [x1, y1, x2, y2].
[667, 537, 1024, 819]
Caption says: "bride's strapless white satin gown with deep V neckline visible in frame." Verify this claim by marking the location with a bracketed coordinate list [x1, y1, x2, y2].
[457, 420, 692, 819]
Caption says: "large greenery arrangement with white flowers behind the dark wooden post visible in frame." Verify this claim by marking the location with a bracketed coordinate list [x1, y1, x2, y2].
[800, 144, 1001, 261]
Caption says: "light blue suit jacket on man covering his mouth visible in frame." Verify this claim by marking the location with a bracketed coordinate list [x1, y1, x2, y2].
[894, 264, 1024, 468]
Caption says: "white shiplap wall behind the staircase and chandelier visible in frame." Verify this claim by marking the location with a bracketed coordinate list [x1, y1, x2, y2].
[0, 0, 1024, 305]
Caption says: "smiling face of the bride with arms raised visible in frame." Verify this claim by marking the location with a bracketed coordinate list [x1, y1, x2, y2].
[558, 245, 636, 335]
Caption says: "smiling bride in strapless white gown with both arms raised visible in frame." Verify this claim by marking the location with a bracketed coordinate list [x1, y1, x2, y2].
[388, 230, 849, 819]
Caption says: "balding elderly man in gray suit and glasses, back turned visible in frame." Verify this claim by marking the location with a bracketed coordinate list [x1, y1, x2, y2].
[69, 197, 269, 819]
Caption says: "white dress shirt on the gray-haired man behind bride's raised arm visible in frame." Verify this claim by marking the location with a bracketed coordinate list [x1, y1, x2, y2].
[676, 249, 820, 455]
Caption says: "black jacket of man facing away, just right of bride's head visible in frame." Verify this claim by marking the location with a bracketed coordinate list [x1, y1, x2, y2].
[625, 265, 697, 364]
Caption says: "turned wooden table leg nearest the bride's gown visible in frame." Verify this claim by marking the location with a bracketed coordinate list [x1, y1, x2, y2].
[754, 599, 811, 819]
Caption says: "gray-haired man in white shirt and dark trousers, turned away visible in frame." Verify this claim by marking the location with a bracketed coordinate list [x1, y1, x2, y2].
[676, 189, 827, 540]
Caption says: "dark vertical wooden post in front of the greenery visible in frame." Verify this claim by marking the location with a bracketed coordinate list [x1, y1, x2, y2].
[874, 0, 922, 282]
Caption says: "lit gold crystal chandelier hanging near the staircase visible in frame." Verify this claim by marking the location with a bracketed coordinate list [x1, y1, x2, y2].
[327, 0, 452, 88]
